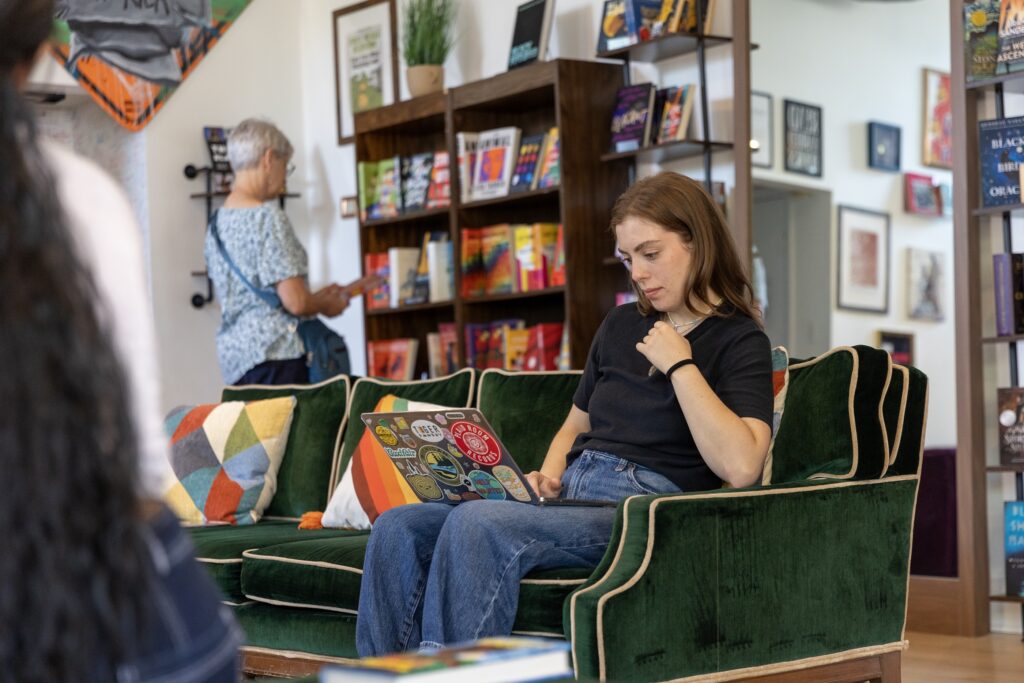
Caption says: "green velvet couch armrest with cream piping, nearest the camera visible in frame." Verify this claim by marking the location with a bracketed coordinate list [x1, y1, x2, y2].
[564, 475, 918, 681]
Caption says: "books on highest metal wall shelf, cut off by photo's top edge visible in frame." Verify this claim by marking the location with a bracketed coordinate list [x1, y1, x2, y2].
[597, 0, 715, 54]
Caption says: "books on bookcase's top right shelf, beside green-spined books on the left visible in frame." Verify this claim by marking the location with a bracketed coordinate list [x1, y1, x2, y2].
[456, 126, 561, 204]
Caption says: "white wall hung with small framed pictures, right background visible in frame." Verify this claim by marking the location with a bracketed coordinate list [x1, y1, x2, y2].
[751, 0, 956, 445]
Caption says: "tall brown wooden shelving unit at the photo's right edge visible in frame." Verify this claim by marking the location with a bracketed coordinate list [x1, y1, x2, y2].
[942, 0, 1024, 636]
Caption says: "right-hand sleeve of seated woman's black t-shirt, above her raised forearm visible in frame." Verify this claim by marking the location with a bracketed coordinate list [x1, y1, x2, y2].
[714, 329, 774, 426]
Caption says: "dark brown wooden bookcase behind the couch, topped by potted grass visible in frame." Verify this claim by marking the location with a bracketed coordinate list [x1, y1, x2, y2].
[355, 59, 629, 377]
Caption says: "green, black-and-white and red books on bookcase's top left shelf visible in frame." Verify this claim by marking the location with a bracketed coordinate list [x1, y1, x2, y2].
[356, 151, 452, 221]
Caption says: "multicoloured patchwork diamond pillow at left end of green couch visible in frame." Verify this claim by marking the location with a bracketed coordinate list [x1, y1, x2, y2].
[164, 396, 295, 524]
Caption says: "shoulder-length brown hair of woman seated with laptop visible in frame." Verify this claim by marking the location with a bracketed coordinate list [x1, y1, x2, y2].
[609, 171, 761, 325]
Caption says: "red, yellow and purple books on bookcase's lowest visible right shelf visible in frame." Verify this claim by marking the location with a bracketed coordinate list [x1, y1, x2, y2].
[465, 318, 569, 371]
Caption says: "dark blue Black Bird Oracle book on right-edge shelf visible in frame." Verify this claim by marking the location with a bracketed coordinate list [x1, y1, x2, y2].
[978, 117, 1024, 207]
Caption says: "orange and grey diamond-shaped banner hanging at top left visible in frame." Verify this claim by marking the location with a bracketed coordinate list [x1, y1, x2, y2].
[50, 0, 252, 131]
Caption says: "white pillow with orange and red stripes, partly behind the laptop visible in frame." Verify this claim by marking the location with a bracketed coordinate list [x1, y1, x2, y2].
[323, 394, 444, 529]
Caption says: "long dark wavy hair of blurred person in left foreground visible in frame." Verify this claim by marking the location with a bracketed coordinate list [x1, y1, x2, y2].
[0, 0, 148, 683]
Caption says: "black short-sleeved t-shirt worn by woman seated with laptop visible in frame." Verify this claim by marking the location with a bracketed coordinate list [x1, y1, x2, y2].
[568, 304, 773, 490]
